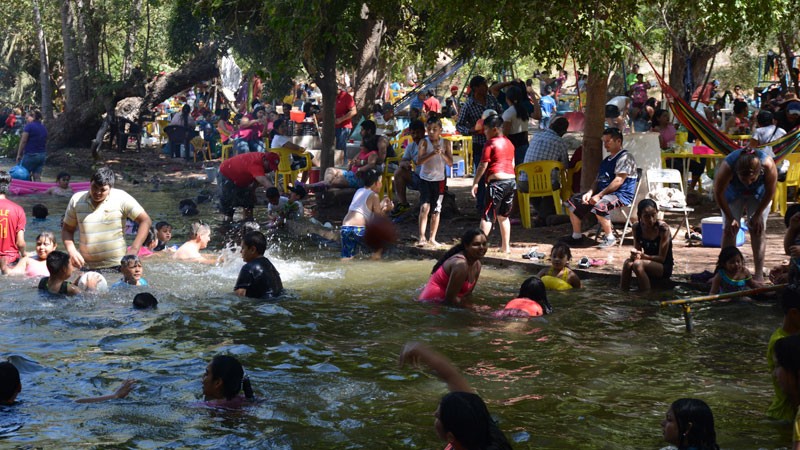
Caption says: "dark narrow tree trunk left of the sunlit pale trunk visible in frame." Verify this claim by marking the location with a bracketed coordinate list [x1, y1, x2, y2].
[312, 42, 339, 174]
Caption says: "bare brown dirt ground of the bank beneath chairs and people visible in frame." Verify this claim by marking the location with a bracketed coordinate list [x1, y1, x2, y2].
[23, 148, 788, 281]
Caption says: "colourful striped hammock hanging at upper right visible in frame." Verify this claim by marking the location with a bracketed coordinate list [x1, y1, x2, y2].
[634, 44, 800, 161]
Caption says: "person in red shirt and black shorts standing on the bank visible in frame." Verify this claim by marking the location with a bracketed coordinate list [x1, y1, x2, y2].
[472, 110, 517, 253]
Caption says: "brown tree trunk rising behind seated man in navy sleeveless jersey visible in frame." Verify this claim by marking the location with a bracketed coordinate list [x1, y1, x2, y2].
[581, 67, 608, 191]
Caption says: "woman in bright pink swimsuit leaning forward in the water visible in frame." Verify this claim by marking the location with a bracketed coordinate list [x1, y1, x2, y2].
[419, 228, 488, 306]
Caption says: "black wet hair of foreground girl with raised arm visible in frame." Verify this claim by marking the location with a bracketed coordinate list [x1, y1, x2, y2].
[439, 392, 511, 450]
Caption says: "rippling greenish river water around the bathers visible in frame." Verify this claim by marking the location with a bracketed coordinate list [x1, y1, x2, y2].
[0, 175, 791, 449]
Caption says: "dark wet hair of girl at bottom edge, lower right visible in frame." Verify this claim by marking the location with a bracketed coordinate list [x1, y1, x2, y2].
[670, 398, 719, 450]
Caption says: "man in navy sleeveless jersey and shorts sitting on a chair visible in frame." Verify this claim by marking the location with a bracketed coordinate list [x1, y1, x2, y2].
[562, 128, 637, 248]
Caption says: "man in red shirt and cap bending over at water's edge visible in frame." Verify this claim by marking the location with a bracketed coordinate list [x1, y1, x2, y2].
[217, 152, 280, 221]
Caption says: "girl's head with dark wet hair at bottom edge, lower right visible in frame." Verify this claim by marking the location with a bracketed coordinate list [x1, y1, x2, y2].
[661, 398, 719, 450]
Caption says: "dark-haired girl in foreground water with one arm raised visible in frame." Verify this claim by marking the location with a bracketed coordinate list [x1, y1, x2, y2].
[400, 342, 511, 450]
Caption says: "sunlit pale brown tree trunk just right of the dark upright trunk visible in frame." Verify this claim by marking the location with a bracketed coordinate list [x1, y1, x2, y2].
[355, 11, 386, 117]
